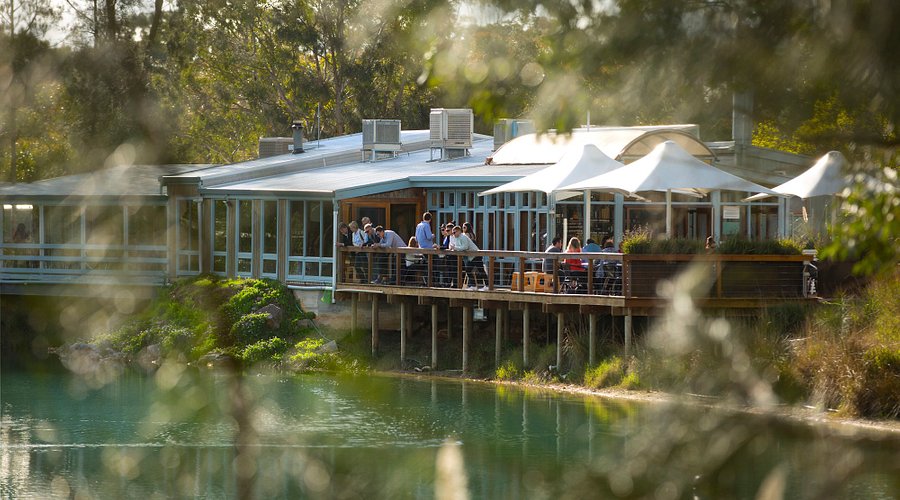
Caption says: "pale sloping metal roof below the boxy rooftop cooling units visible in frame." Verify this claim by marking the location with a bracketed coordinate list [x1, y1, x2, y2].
[201, 136, 493, 199]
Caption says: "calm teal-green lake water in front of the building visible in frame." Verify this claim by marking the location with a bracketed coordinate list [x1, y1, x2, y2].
[0, 365, 900, 499]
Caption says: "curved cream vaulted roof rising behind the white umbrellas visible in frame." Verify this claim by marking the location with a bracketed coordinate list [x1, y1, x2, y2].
[491, 125, 715, 165]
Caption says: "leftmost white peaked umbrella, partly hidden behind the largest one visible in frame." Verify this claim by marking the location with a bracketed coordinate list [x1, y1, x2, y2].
[478, 144, 622, 200]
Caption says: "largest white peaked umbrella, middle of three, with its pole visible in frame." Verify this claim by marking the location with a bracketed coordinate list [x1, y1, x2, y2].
[558, 141, 775, 235]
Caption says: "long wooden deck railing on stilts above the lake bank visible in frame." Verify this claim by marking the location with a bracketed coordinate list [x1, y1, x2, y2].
[337, 248, 815, 299]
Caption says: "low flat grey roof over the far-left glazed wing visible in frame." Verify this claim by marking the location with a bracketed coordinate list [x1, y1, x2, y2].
[0, 164, 205, 199]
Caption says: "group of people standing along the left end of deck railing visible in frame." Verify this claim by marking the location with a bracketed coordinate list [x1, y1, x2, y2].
[336, 212, 487, 289]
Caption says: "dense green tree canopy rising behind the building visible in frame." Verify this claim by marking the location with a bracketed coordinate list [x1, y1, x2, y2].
[0, 0, 900, 270]
